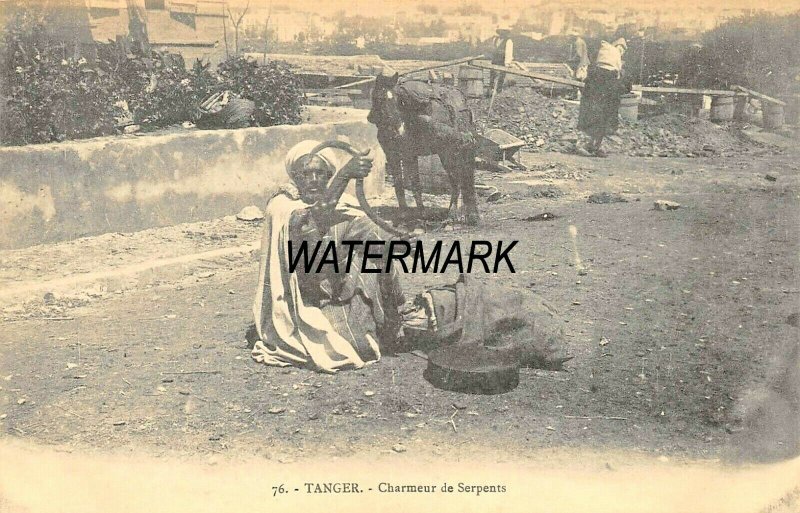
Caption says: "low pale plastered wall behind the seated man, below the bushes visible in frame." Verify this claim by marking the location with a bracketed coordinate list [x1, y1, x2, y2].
[0, 121, 385, 249]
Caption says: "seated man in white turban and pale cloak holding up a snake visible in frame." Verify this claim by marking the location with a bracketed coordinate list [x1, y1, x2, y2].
[252, 141, 403, 372]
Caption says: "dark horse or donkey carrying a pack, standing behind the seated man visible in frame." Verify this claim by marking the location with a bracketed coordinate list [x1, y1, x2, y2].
[367, 74, 480, 225]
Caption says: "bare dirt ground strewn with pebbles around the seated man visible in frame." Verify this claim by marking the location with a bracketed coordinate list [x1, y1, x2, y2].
[0, 140, 800, 472]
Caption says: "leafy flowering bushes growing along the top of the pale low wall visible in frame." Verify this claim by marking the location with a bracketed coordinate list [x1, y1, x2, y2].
[0, 6, 303, 145]
